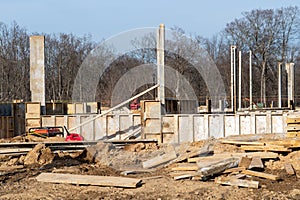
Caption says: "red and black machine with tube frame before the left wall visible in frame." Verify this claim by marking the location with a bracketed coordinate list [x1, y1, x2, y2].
[28, 126, 84, 141]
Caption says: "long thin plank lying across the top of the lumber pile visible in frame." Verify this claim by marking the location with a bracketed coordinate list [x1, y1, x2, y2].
[188, 152, 278, 163]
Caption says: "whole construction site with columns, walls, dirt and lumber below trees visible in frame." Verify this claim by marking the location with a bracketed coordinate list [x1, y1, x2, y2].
[0, 24, 300, 199]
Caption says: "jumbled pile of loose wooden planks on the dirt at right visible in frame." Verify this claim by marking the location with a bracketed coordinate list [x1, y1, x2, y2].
[170, 138, 300, 188]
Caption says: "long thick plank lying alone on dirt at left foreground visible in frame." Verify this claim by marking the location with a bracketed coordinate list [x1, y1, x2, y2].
[36, 173, 142, 188]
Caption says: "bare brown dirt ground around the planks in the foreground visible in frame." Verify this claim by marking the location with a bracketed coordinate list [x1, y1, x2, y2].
[0, 135, 300, 200]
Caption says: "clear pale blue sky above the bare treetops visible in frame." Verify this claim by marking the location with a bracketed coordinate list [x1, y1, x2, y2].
[0, 0, 300, 41]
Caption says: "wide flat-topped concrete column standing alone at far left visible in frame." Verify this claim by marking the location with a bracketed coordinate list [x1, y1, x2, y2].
[30, 36, 45, 114]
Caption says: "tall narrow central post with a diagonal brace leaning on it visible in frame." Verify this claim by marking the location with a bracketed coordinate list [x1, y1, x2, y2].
[157, 24, 165, 106]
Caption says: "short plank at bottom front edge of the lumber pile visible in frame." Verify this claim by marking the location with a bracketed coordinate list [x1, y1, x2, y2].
[215, 177, 259, 188]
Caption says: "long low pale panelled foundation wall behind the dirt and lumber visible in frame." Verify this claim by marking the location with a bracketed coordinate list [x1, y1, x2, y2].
[42, 112, 296, 143]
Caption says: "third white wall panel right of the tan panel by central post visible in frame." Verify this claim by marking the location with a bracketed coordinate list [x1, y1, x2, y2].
[209, 115, 224, 138]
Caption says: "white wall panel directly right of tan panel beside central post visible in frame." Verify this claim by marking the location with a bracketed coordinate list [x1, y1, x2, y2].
[178, 115, 194, 142]
